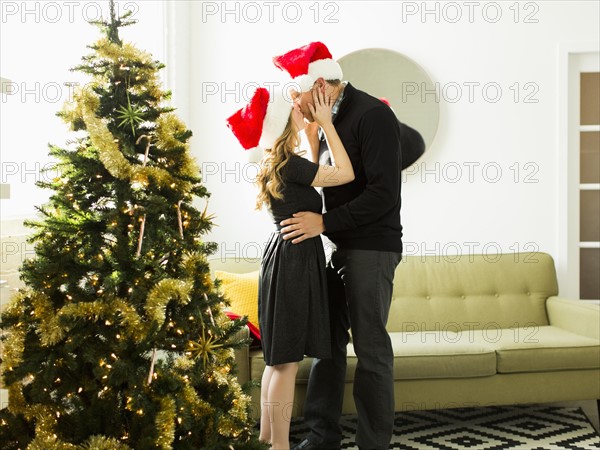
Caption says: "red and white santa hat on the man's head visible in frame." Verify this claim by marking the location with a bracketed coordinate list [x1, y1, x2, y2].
[273, 42, 343, 92]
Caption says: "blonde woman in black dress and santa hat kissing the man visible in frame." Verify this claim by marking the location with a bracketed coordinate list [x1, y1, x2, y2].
[228, 87, 354, 449]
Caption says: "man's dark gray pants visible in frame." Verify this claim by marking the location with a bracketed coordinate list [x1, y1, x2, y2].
[304, 248, 401, 449]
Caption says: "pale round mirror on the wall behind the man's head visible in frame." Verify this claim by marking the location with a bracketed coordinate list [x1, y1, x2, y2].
[338, 48, 440, 149]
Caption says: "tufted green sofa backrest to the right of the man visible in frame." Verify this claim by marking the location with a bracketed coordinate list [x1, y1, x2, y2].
[387, 253, 558, 332]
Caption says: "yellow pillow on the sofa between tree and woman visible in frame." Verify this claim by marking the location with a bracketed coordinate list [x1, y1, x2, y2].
[215, 270, 259, 338]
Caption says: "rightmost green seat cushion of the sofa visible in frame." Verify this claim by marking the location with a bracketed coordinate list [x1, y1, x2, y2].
[464, 326, 600, 373]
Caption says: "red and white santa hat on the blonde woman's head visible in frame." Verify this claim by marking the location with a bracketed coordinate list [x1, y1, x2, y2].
[227, 87, 292, 150]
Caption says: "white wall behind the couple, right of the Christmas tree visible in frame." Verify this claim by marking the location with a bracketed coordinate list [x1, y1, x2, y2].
[162, 1, 600, 294]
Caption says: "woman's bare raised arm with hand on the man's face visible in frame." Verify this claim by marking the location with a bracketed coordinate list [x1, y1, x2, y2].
[308, 89, 354, 187]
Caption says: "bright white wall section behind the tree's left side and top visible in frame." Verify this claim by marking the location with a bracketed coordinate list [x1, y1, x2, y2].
[0, 0, 165, 221]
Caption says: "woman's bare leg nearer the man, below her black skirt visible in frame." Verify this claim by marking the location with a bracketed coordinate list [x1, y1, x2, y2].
[268, 362, 298, 450]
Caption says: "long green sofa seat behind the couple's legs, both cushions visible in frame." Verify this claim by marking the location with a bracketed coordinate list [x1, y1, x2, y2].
[250, 326, 600, 383]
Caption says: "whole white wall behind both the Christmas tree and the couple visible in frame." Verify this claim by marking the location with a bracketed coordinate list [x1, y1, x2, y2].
[0, 1, 600, 298]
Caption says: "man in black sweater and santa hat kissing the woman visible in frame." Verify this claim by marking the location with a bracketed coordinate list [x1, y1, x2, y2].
[274, 42, 402, 450]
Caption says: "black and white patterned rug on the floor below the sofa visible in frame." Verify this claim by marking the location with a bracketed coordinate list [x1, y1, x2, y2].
[290, 405, 600, 450]
